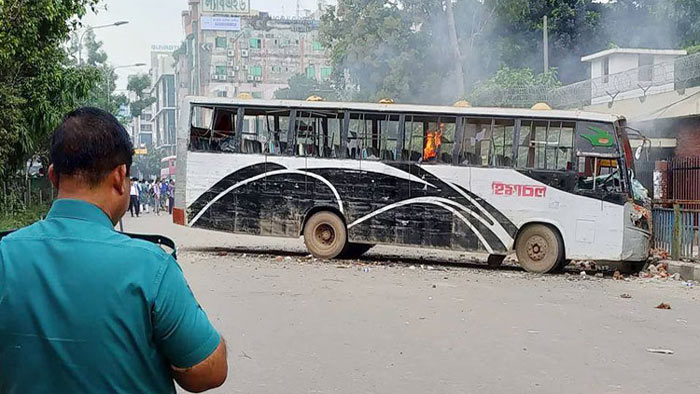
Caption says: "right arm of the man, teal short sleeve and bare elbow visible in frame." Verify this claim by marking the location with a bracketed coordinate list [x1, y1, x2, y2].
[153, 257, 228, 393]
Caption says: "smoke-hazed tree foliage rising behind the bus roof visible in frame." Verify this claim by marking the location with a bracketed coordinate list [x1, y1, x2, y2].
[321, 0, 700, 104]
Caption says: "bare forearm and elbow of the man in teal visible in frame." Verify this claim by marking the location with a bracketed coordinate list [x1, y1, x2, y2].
[172, 337, 228, 393]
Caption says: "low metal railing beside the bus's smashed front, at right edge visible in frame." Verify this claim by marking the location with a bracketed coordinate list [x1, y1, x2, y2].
[652, 204, 700, 260]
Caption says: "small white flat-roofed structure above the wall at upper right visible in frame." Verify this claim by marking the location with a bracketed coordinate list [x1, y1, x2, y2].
[581, 48, 687, 104]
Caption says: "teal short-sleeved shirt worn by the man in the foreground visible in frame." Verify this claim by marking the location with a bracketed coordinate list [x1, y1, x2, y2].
[0, 200, 219, 394]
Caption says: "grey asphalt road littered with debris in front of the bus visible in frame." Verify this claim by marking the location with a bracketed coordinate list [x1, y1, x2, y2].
[124, 215, 700, 394]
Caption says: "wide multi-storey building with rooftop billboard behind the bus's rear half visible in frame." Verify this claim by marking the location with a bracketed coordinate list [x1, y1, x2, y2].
[176, 0, 331, 107]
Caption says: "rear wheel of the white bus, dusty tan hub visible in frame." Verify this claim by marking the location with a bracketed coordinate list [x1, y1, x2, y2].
[304, 211, 347, 259]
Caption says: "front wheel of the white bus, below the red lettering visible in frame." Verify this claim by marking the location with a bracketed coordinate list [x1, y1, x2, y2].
[515, 224, 564, 274]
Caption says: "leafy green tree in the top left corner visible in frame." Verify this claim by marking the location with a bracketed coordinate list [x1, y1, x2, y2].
[0, 0, 99, 177]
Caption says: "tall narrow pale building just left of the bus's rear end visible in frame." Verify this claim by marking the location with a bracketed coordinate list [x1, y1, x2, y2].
[150, 45, 179, 155]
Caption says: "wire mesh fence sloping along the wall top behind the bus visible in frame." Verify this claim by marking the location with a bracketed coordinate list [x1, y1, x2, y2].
[474, 53, 700, 108]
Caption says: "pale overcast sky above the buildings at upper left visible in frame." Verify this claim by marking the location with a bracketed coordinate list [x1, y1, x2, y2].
[84, 0, 335, 89]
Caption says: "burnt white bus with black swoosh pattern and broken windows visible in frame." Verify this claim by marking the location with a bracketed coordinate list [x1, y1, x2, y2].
[173, 98, 650, 273]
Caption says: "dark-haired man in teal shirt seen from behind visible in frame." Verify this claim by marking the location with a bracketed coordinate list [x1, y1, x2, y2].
[0, 108, 228, 394]
